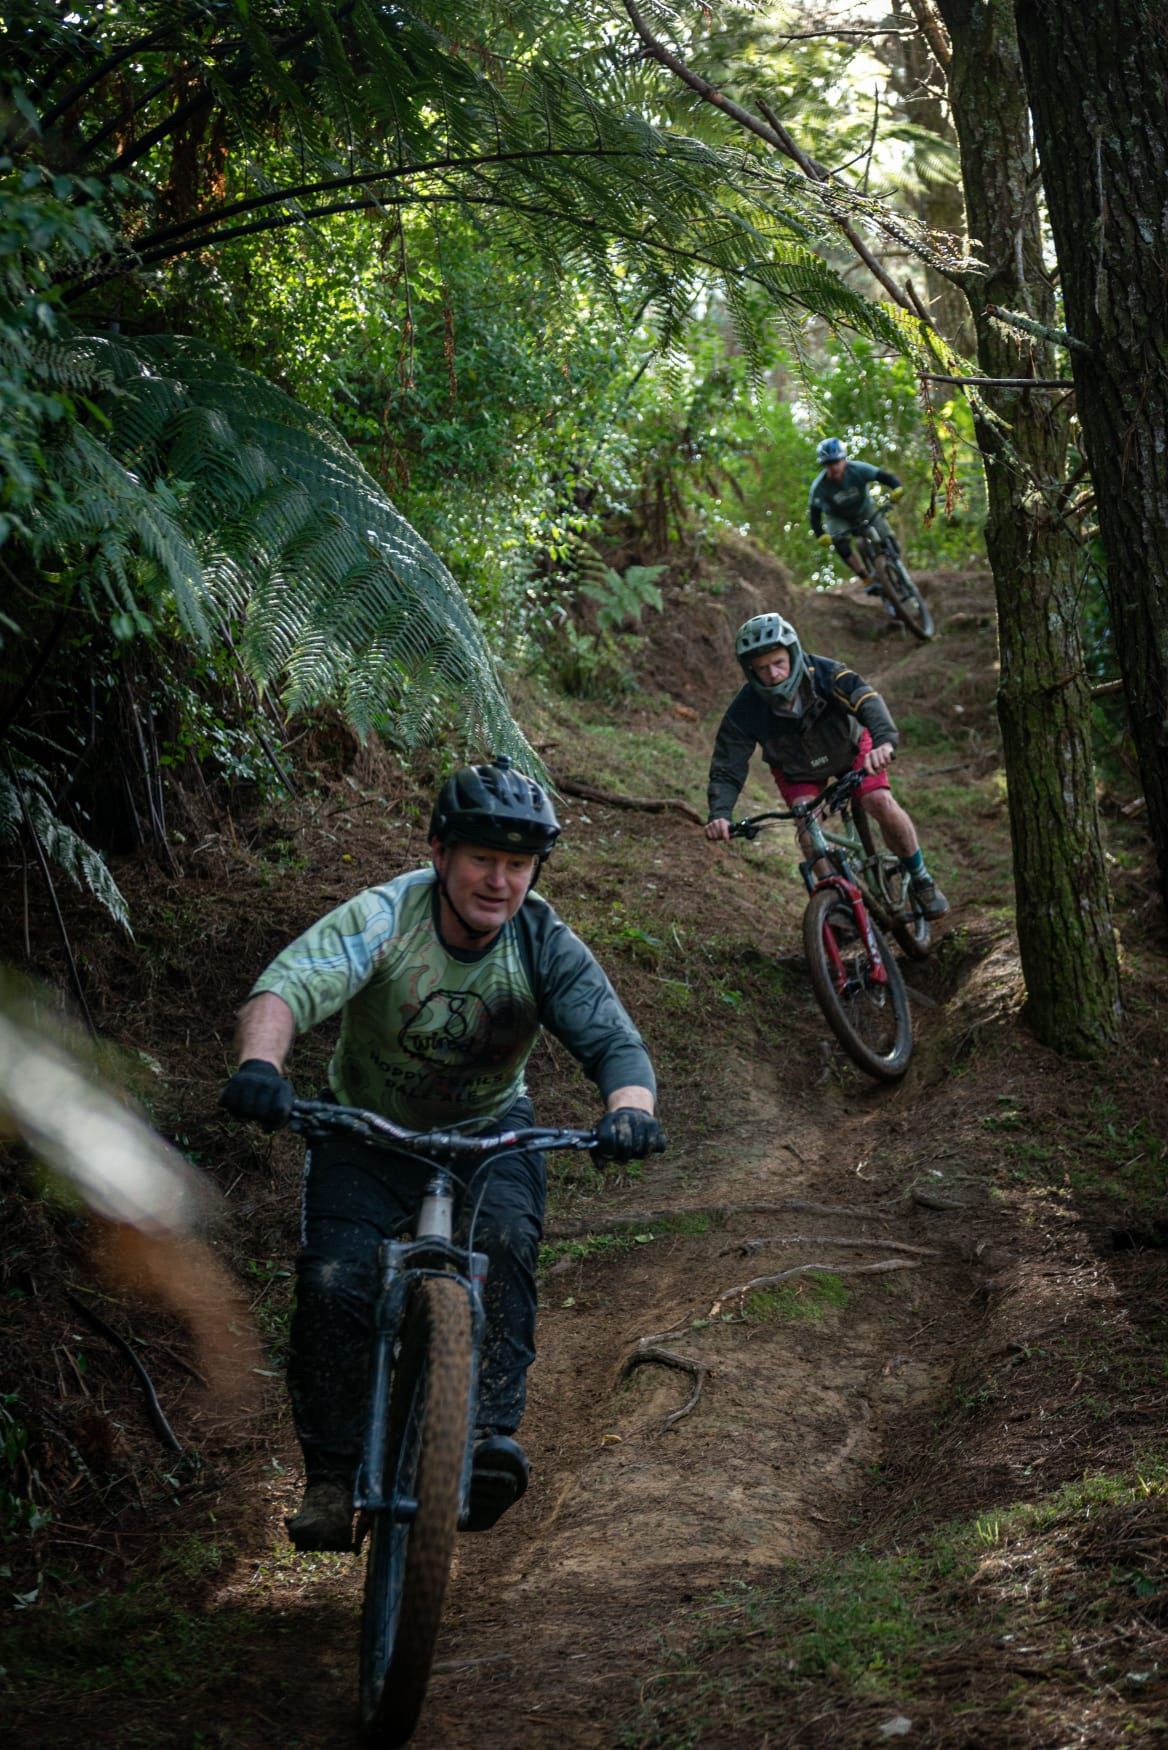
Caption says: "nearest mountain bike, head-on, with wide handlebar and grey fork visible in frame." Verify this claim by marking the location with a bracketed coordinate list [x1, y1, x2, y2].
[291, 1099, 597, 1747]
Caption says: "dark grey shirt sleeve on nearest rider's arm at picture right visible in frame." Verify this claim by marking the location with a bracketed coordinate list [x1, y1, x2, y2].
[518, 894, 657, 1099]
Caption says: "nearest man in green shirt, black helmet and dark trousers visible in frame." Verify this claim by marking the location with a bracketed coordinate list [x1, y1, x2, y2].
[221, 758, 664, 1549]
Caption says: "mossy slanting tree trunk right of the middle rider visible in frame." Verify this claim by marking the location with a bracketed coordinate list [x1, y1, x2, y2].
[939, 0, 1119, 1055]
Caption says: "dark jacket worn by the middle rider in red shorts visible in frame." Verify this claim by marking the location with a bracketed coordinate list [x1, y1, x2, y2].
[709, 656, 900, 821]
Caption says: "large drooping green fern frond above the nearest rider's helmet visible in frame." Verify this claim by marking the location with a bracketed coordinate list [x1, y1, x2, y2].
[40, 334, 538, 765]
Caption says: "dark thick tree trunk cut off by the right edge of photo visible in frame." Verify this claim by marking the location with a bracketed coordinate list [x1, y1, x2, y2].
[1014, 0, 1168, 901]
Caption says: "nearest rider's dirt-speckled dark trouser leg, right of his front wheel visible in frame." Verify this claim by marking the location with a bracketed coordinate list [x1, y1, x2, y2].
[464, 1113, 546, 1433]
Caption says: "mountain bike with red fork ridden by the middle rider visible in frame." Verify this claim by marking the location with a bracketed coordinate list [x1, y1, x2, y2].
[730, 772, 932, 1082]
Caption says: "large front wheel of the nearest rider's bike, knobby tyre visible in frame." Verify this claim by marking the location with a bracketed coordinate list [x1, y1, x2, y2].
[361, 1276, 471, 1747]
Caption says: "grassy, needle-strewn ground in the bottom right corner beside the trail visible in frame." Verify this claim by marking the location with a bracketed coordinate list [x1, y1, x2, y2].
[620, 1458, 1168, 1750]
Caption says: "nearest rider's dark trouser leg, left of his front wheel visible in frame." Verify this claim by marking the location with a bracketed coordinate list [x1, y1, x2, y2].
[287, 1141, 425, 1482]
